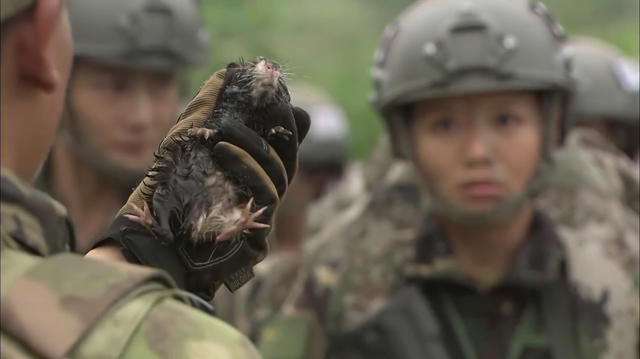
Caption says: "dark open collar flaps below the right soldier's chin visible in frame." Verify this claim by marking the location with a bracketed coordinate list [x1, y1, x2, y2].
[405, 212, 564, 288]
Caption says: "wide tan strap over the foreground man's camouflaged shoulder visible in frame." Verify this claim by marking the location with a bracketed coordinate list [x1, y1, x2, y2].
[0, 253, 177, 358]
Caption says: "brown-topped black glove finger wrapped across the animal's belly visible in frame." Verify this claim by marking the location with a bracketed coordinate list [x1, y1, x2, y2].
[213, 142, 279, 218]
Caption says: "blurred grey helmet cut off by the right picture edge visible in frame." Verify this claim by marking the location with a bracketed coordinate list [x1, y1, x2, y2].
[568, 37, 640, 125]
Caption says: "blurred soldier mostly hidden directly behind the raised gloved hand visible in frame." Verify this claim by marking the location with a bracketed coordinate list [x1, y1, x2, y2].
[214, 83, 352, 338]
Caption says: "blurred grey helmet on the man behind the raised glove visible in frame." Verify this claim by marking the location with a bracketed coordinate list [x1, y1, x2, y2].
[69, 0, 209, 70]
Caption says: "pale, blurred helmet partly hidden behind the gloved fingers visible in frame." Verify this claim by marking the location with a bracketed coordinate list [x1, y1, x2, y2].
[289, 83, 349, 172]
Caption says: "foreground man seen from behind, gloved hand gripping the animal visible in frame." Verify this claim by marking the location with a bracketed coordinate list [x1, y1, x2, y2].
[0, 0, 308, 358]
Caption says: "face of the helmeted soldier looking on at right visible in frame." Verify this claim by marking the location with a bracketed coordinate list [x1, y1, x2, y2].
[410, 92, 542, 213]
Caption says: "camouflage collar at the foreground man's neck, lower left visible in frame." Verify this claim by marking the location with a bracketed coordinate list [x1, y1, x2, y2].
[0, 168, 75, 256]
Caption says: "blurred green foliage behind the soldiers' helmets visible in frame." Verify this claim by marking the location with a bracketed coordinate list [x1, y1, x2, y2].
[188, 0, 640, 158]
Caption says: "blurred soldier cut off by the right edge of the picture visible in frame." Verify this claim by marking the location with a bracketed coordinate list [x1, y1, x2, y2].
[553, 38, 640, 216]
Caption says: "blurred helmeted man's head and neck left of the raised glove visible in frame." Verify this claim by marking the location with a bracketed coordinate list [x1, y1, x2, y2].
[38, 0, 209, 252]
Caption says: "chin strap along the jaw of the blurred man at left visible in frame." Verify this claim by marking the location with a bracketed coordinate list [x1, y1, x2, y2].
[59, 101, 145, 191]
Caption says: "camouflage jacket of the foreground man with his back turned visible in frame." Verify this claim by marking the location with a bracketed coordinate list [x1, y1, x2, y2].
[0, 168, 259, 358]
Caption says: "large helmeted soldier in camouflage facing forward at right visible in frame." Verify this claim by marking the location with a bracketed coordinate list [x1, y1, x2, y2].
[259, 0, 638, 359]
